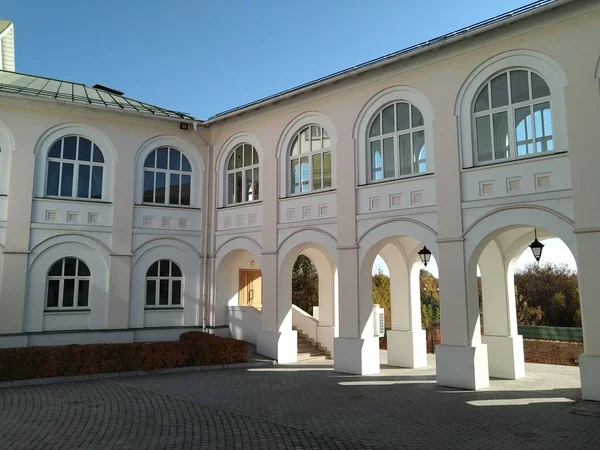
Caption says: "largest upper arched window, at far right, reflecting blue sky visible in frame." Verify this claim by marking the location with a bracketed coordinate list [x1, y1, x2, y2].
[473, 69, 554, 163]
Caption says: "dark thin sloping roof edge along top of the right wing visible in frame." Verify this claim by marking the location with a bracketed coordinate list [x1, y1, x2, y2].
[206, 0, 572, 125]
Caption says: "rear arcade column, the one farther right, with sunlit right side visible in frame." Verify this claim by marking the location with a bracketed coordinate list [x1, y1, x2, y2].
[479, 241, 525, 380]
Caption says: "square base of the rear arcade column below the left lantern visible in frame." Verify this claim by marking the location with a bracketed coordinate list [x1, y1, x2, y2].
[387, 330, 427, 369]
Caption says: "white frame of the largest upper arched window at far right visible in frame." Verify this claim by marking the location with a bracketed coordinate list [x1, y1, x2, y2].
[471, 67, 555, 166]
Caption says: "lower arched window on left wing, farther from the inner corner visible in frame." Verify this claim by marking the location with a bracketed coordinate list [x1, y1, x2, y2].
[46, 257, 92, 310]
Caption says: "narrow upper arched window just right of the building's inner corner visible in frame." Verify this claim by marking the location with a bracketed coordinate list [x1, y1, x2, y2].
[226, 144, 259, 205]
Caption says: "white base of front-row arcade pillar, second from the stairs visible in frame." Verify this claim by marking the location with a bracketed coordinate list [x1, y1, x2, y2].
[333, 337, 379, 375]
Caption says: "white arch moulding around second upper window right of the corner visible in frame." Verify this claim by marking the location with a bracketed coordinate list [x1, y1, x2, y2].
[277, 111, 338, 198]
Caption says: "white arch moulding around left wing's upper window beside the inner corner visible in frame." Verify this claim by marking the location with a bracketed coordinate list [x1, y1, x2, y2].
[134, 135, 206, 208]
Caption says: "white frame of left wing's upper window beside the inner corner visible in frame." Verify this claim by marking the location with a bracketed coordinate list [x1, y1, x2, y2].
[142, 145, 194, 208]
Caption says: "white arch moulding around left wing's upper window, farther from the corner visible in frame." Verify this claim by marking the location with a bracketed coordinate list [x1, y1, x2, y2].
[33, 123, 118, 202]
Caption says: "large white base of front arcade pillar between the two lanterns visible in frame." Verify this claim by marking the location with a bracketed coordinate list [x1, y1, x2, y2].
[435, 344, 490, 390]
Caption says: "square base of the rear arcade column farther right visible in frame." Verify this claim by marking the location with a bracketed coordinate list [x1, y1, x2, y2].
[481, 335, 525, 380]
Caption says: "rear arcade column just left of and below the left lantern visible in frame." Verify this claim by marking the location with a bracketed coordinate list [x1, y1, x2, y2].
[379, 244, 427, 368]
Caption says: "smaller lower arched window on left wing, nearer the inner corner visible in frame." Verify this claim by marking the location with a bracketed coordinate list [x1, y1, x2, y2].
[146, 259, 183, 308]
